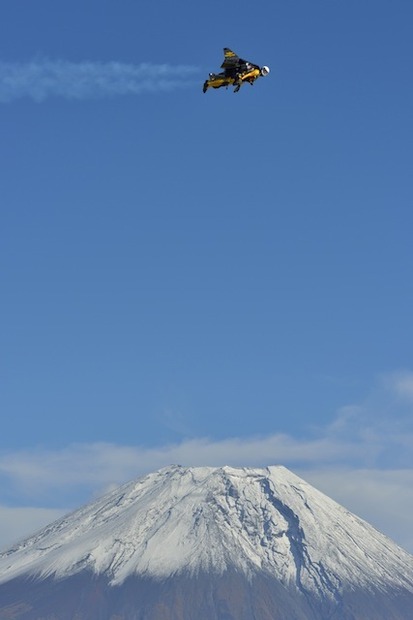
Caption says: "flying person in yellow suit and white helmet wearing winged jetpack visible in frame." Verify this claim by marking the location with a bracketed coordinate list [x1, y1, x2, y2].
[202, 47, 270, 93]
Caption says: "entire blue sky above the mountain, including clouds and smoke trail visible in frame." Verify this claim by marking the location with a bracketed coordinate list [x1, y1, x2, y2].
[0, 0, 413, 551]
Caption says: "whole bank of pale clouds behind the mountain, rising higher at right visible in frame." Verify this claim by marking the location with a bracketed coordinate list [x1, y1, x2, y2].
[0, 372, 413, 551]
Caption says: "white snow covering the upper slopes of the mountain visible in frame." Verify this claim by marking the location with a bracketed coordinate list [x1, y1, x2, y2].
[0, 466, 413, 600]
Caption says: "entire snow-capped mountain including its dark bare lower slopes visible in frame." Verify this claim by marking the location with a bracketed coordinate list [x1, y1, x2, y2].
[0, 466, 413, 620]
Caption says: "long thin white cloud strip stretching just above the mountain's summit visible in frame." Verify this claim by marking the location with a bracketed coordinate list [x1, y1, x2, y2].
[0, 434, 366, 497]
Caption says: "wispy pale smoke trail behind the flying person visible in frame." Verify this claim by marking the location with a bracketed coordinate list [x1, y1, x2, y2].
[0, 59, 198, 103]
